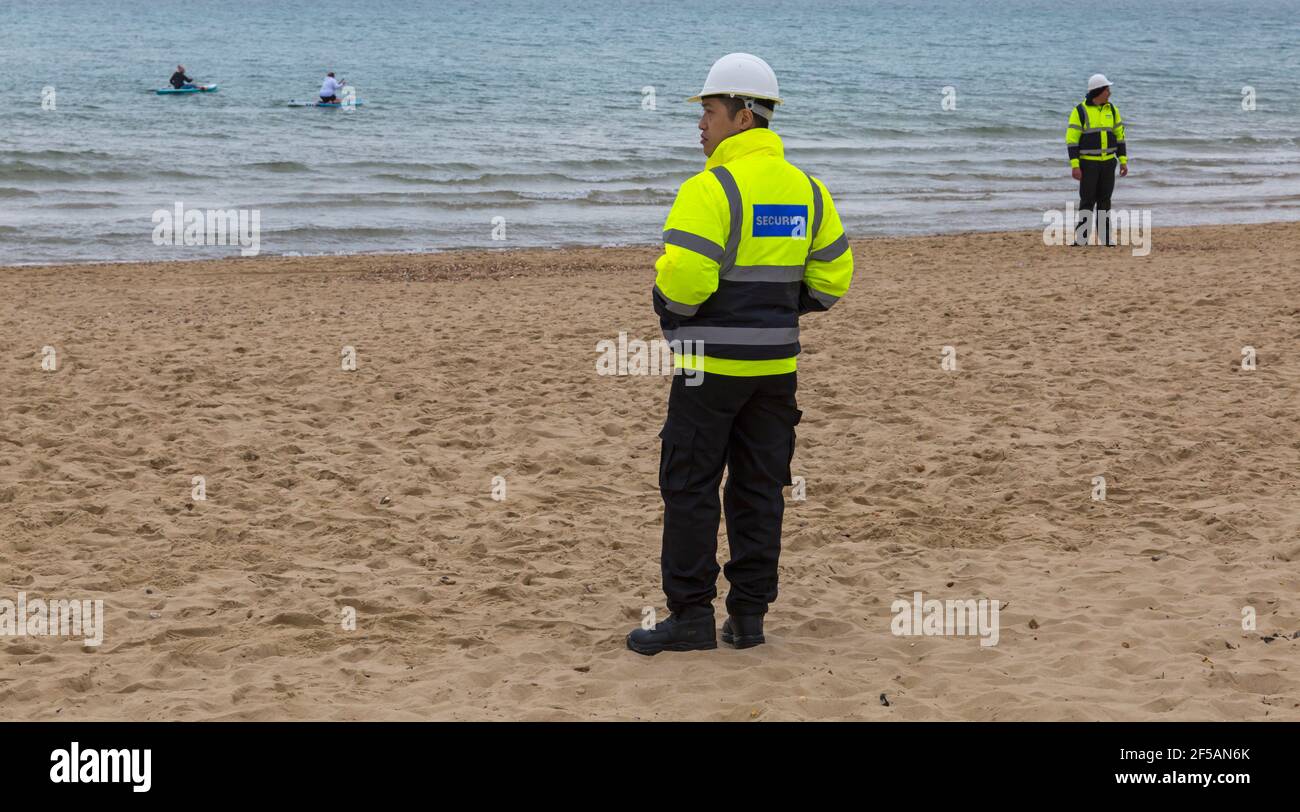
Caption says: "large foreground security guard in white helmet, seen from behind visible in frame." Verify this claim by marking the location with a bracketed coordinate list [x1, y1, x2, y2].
[628, 53, 853, 655]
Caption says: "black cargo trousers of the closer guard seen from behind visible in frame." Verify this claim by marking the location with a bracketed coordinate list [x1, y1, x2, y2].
[659, 373, 802, 617]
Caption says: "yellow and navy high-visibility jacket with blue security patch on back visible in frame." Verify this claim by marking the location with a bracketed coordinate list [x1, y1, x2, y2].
[654, 127, 853, 375]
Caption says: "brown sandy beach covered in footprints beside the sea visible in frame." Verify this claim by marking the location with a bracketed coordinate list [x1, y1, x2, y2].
[0, 223, 1300, 720]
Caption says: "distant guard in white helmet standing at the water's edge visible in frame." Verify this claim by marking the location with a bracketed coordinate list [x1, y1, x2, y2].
[1065, 73, 1128, 246]
